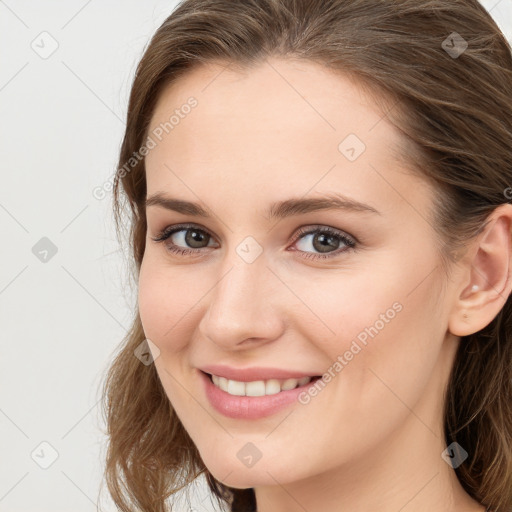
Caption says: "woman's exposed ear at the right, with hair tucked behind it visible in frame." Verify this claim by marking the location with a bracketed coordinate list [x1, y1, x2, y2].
[448, 203, 512, 336]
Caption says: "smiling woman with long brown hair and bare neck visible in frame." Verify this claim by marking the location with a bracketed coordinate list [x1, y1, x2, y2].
[100, 0, 512, 512]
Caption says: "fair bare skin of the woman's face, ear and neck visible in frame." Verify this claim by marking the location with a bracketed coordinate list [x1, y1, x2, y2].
[138, 58, 512, 512]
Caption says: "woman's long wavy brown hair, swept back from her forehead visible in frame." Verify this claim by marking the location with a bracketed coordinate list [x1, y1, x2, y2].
[103, 0, 512, 512]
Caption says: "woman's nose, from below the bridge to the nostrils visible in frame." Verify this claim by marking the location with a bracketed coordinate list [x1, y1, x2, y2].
[198, 254, 284, 350]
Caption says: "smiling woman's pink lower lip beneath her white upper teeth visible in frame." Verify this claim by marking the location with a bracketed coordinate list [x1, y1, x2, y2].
[198, 370, 318, 420]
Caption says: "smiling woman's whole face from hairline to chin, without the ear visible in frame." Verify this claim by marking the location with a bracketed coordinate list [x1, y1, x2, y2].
[138, 59, 458, 488]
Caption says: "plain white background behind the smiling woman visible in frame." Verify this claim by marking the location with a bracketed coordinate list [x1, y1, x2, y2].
[0, 0, 512, 512]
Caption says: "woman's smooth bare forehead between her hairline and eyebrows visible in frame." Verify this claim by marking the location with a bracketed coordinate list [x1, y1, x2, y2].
[142, 59, 430, 221]
